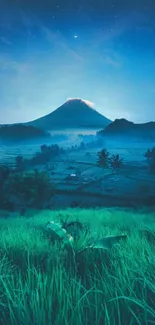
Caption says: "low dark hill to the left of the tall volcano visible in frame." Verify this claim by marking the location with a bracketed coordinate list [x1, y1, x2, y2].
[0, 124, 51, 144]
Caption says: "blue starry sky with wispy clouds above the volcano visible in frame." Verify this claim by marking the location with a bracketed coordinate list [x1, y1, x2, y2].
[0, 0, 155, 124]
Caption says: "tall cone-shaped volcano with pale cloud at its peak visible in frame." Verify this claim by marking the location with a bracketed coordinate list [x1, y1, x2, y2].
[26, 99, 111, 131]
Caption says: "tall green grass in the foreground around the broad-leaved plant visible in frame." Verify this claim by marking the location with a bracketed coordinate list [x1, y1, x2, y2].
[0, 209, 155, 325]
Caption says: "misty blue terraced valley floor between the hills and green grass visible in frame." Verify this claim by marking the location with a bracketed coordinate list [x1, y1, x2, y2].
[0, 142, 155, 208]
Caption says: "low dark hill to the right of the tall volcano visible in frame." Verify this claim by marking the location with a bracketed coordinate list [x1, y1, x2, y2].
[97, 119, 155, 140]
